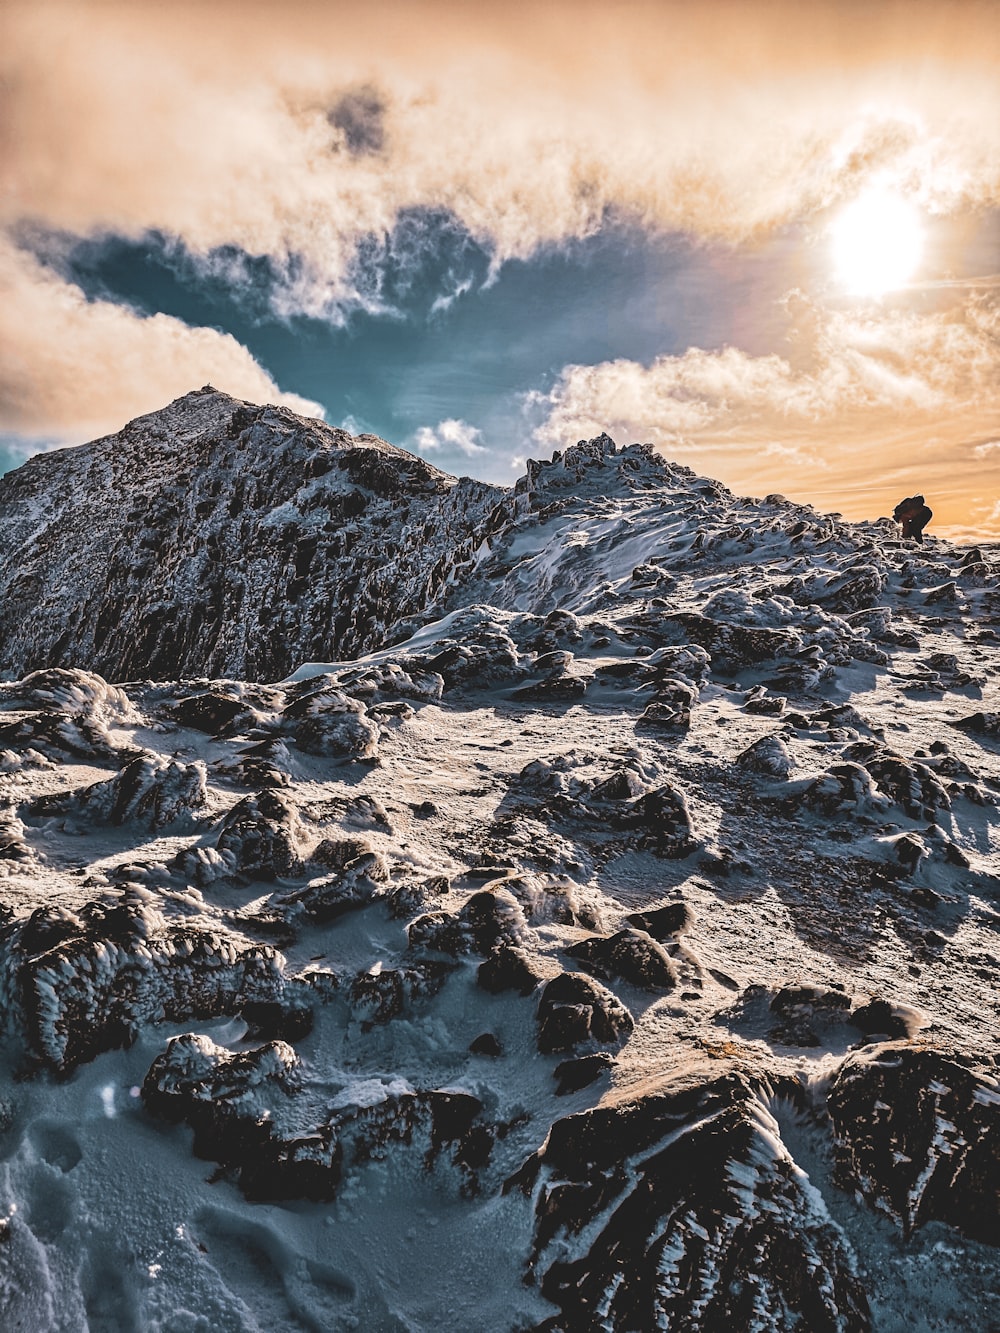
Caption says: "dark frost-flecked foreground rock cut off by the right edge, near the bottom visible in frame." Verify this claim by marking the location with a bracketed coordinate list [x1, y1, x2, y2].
[828, 1042, 1000, 1245]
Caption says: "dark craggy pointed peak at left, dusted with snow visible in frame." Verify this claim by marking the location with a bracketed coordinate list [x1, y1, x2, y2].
[0, 387, 503, 677]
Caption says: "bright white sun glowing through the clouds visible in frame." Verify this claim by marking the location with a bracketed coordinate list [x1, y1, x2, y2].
[831, 187, 924, 296]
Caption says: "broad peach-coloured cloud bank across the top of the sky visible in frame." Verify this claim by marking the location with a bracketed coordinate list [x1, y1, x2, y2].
[0, 0, 1000, 317]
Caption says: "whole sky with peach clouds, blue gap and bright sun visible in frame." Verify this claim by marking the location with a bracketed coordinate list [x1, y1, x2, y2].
[0, 0, 1000, 541]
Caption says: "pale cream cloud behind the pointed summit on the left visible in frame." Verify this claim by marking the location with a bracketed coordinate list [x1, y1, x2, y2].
[0, 239, 323, 443]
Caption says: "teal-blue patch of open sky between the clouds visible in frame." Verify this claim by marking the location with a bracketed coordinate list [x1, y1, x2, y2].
[11, 209, 797, 481]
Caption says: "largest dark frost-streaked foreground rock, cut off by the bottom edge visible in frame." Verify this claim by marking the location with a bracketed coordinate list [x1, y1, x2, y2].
[507, 1074, 871, 1333]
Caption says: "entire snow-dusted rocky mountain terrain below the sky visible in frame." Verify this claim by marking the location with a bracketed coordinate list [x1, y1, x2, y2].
[0, 389, 1000, 1333]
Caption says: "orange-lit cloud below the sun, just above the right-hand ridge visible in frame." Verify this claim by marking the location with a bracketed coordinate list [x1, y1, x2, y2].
[529, 296, 1000, 536]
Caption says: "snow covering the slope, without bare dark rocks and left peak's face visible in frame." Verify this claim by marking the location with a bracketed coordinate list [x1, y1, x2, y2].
[0, 393, 1000, 1333]
